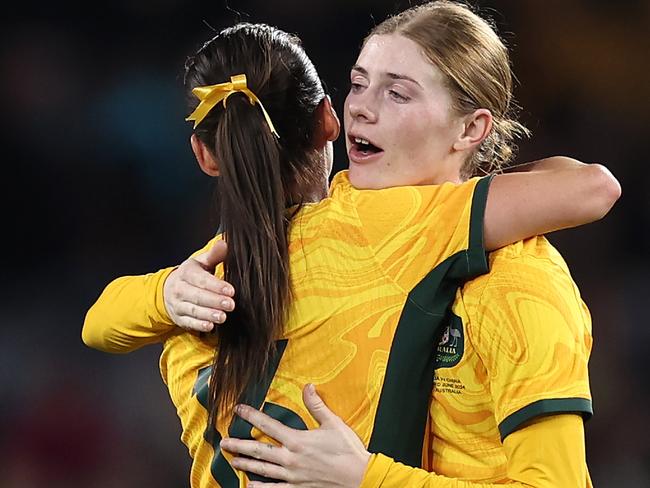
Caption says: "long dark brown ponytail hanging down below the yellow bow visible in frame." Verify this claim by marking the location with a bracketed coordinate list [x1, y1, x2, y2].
[210, 94, 289, 416]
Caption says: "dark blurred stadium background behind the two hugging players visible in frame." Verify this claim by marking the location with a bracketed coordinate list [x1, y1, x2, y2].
[0, 0, 650, 488]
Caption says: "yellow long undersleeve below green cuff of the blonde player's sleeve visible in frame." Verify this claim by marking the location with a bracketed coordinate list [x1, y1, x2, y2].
[360, 415, 591, 488]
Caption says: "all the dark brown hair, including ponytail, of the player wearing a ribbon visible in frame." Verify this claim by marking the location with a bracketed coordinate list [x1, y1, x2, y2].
[185, 24, 324, 422]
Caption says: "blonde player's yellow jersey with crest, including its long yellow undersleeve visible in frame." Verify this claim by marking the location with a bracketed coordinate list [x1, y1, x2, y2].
[362, 237, 592, 488]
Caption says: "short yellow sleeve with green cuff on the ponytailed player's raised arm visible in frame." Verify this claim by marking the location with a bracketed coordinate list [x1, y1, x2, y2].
[356, 176, 491, 290]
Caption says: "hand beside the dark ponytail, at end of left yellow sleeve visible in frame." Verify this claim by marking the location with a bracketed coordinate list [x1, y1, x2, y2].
[163, 240, 235, 332]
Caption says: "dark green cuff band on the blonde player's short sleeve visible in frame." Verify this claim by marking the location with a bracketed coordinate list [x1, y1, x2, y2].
[499, 398, 594, 441]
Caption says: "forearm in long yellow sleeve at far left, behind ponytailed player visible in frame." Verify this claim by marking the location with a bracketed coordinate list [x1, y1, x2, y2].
[82, 268, 174, 353]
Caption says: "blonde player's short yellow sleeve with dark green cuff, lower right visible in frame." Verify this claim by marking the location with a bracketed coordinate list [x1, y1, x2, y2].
[461, 237, 592, 439]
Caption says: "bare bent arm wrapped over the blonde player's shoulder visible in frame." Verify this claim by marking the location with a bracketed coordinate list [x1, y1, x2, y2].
[485, 156, 621, 251]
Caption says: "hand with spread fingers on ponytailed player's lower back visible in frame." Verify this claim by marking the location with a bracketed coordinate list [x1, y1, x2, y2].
[220, 385, 370, 488]
